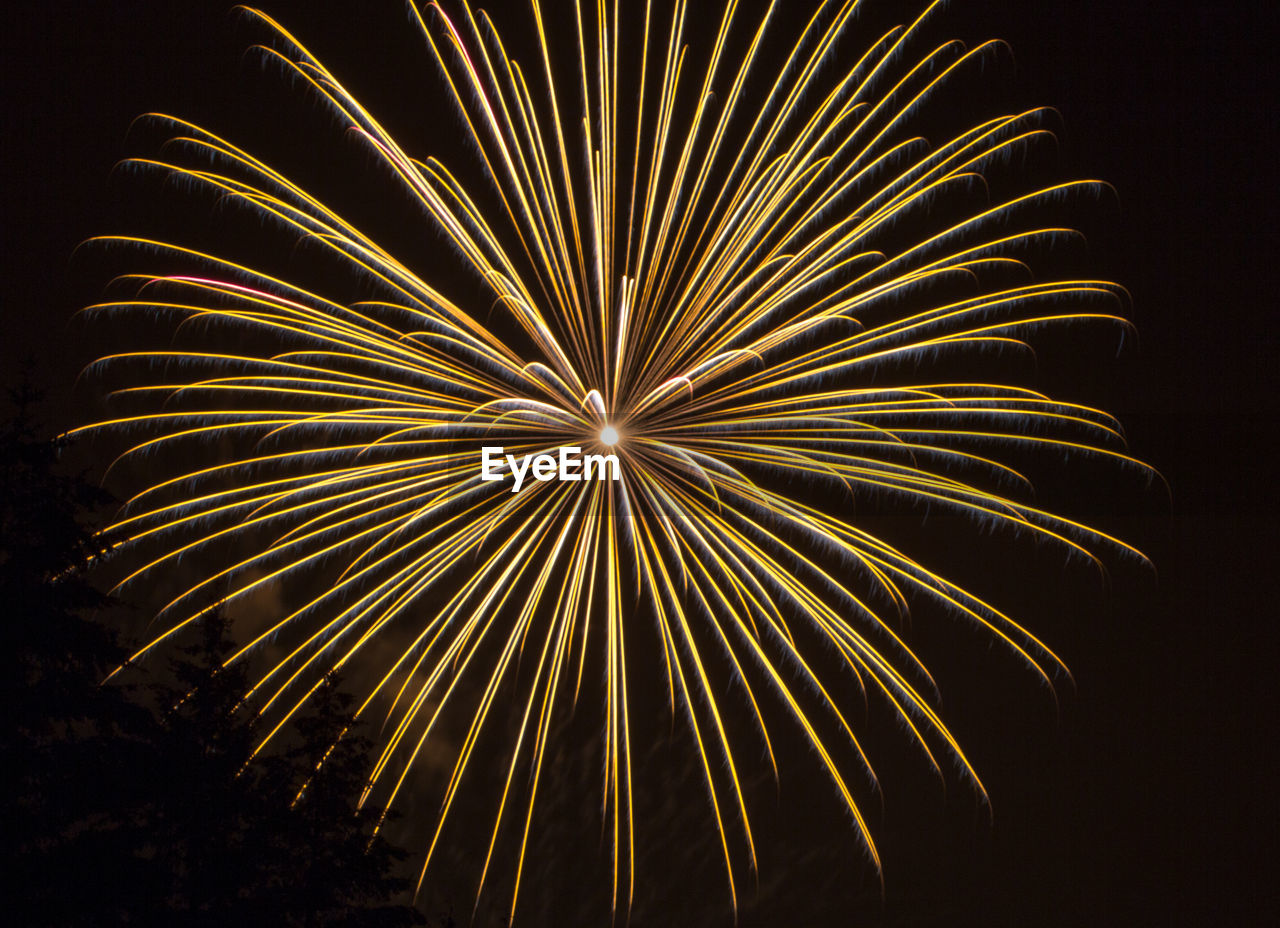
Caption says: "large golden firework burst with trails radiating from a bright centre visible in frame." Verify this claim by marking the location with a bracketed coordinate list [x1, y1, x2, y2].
[74, 0, 1157, 913]
